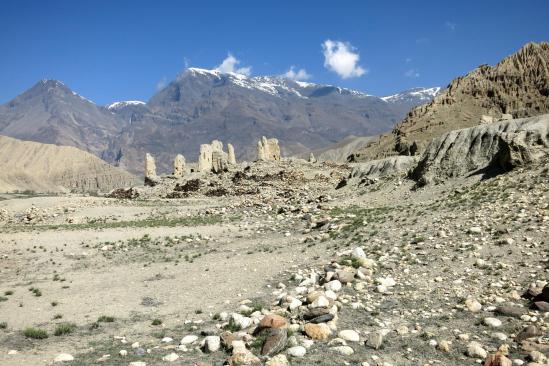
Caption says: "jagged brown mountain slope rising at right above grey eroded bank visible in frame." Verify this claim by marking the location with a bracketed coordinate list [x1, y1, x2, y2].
[349, 42, 549, 161]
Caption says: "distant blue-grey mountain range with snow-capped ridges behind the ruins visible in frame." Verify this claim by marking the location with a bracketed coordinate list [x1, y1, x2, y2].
[0, 68, 432, 174]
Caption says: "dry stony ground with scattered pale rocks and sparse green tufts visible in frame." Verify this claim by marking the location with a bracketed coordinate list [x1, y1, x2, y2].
[0, 160, 549, 366]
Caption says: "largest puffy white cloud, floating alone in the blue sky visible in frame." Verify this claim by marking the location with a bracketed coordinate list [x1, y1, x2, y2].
[322, 39, 368, 79]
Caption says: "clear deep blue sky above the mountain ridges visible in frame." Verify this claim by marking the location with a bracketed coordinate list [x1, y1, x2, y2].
[0, 0, 549, 104]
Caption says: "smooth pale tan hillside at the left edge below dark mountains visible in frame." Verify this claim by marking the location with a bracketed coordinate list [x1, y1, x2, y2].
[0, 136, 136, 192]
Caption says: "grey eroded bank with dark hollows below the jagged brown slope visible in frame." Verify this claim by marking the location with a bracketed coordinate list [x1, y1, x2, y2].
[411, 115, 549, 185]
